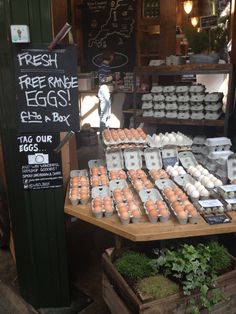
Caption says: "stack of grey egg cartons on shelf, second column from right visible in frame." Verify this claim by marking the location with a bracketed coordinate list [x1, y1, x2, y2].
[189, 84, 206, 120]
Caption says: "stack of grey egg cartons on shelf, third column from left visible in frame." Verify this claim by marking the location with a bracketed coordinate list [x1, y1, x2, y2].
[163, 85, 178, 119]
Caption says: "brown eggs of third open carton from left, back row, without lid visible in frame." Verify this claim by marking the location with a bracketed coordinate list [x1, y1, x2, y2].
[128, 169, 154, 192]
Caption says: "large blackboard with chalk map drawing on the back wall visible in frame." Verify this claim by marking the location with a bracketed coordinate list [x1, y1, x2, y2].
[83, 0, 136, 72]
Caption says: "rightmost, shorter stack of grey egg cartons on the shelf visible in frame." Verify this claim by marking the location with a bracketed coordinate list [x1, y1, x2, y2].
[204, 92, 224, 120]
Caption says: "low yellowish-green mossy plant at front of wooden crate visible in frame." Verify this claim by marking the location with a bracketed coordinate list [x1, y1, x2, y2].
[136, 275, 180, 300]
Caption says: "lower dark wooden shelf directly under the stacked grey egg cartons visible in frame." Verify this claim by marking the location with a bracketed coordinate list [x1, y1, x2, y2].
[135, 116, 225, 127]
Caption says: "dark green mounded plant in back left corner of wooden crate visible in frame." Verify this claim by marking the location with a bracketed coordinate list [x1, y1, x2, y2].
[114, 251, 154, 280]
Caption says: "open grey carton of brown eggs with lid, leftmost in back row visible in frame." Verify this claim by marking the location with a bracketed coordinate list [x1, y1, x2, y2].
[88, 159, 109, 187]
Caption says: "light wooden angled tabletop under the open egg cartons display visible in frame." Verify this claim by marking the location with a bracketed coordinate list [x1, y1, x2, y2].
[65, 194, 236, 242]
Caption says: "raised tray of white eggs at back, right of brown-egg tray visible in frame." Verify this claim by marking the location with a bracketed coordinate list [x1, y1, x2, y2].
[148, 132, 192, 148]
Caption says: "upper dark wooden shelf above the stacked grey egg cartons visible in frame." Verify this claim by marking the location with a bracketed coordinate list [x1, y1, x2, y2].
[136, 63, 233, 76]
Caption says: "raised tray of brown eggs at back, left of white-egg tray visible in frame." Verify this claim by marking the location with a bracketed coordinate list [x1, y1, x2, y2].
[103, 128, 147, 146]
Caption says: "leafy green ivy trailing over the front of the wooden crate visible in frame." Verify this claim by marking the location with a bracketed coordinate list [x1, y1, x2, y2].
[152, 244, 230, 313]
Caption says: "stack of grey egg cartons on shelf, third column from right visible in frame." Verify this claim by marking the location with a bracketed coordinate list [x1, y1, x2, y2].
[175, 85, 190, 119]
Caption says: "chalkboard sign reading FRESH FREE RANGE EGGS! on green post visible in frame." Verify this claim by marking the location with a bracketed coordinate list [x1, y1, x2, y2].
[15, 44, 79, 132]
